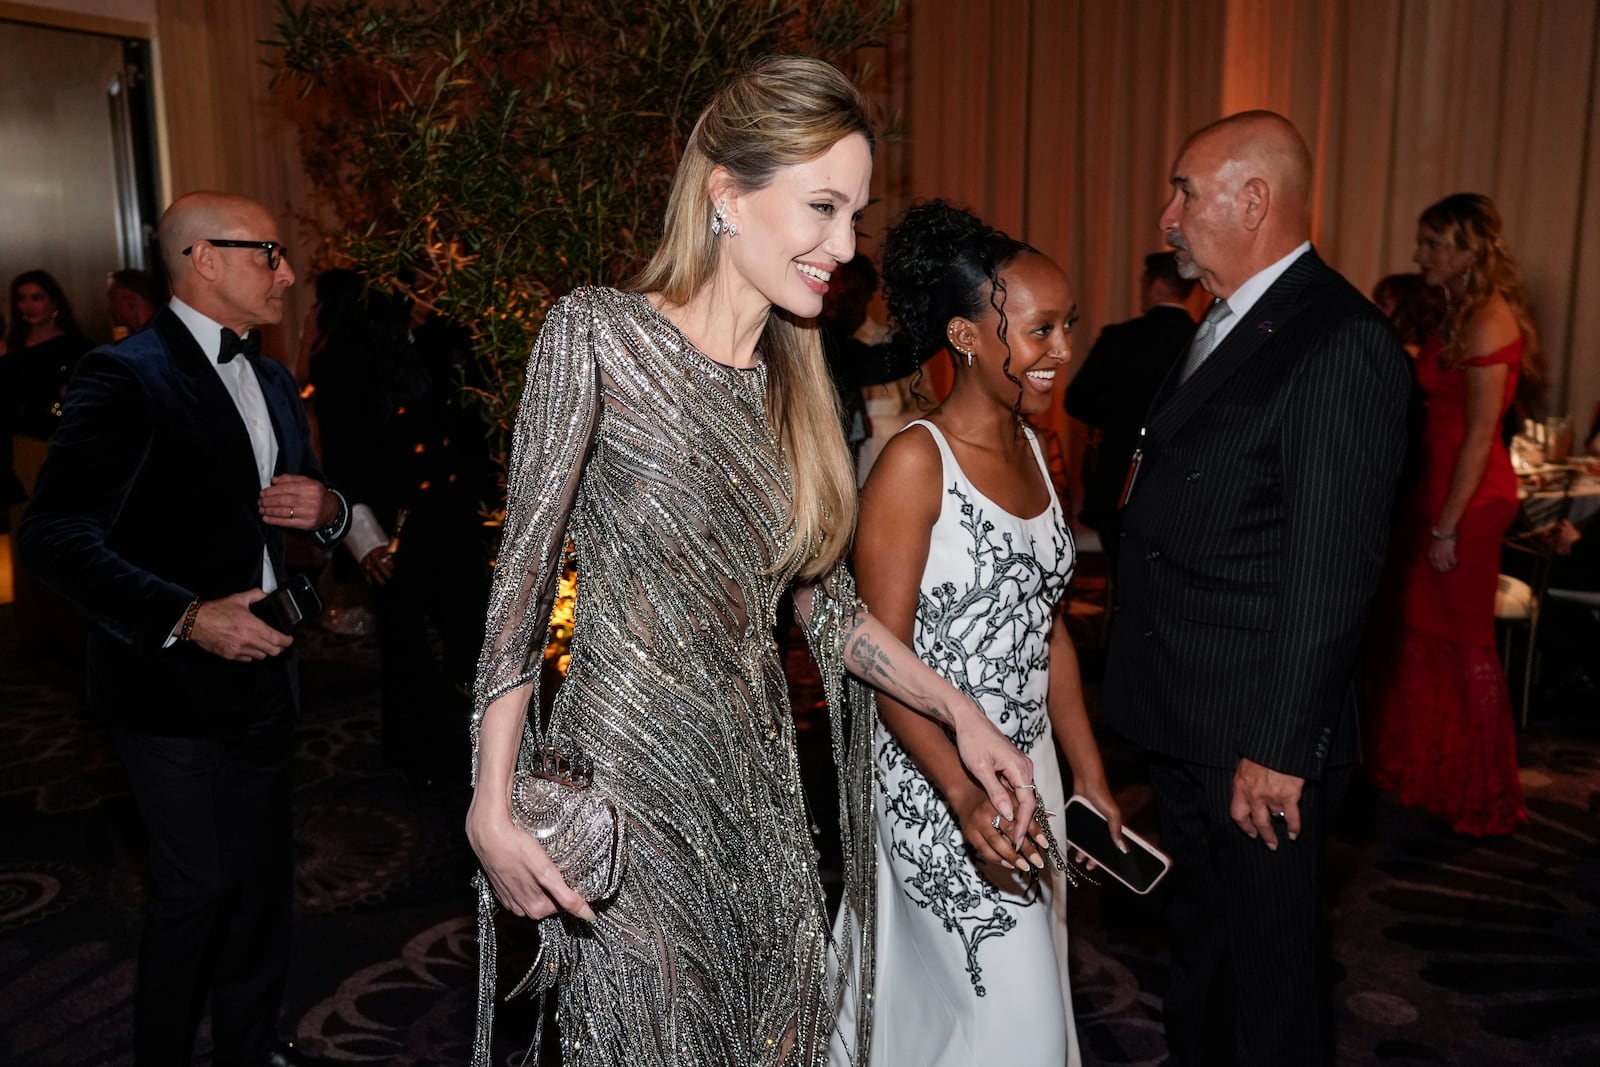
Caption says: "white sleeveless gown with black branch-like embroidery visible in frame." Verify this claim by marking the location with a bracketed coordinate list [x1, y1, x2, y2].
[832, 419, 1078, 1067]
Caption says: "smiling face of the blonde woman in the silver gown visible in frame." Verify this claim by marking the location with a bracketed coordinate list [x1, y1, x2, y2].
[712, 133, 872, 318]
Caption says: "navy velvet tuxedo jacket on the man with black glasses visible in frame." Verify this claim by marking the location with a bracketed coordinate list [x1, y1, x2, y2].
[18, 309, 347, 736]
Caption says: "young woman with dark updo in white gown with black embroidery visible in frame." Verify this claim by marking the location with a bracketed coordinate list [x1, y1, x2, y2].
[843, 200, 1120, 1067]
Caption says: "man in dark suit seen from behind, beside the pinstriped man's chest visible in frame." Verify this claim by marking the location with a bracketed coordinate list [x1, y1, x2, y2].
[1067, 251, 1195, 568]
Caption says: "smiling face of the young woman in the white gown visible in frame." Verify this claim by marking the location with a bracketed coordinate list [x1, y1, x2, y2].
[949, 251, 1078, 414]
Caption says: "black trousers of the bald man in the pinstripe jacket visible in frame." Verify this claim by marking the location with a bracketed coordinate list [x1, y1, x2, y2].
[1150, 757, 1352, 1067]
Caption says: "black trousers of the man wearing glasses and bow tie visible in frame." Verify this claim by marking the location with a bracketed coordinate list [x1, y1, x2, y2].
[112, 691, 294, 1067]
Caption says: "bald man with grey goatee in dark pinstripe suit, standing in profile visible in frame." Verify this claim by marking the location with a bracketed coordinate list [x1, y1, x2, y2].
[1106, 112, 1411, 1067]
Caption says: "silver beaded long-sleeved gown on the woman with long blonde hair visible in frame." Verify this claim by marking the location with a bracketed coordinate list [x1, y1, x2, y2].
[474, 288, 872, 1067]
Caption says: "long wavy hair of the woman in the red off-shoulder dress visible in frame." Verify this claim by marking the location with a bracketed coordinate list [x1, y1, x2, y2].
[1418, 192, 1544, 392]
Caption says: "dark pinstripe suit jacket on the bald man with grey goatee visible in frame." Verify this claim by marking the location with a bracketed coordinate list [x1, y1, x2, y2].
[1106, 251, 1411, 779]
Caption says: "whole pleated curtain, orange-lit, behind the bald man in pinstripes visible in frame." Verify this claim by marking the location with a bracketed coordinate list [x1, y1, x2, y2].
[889, 0, 1600, 505]
